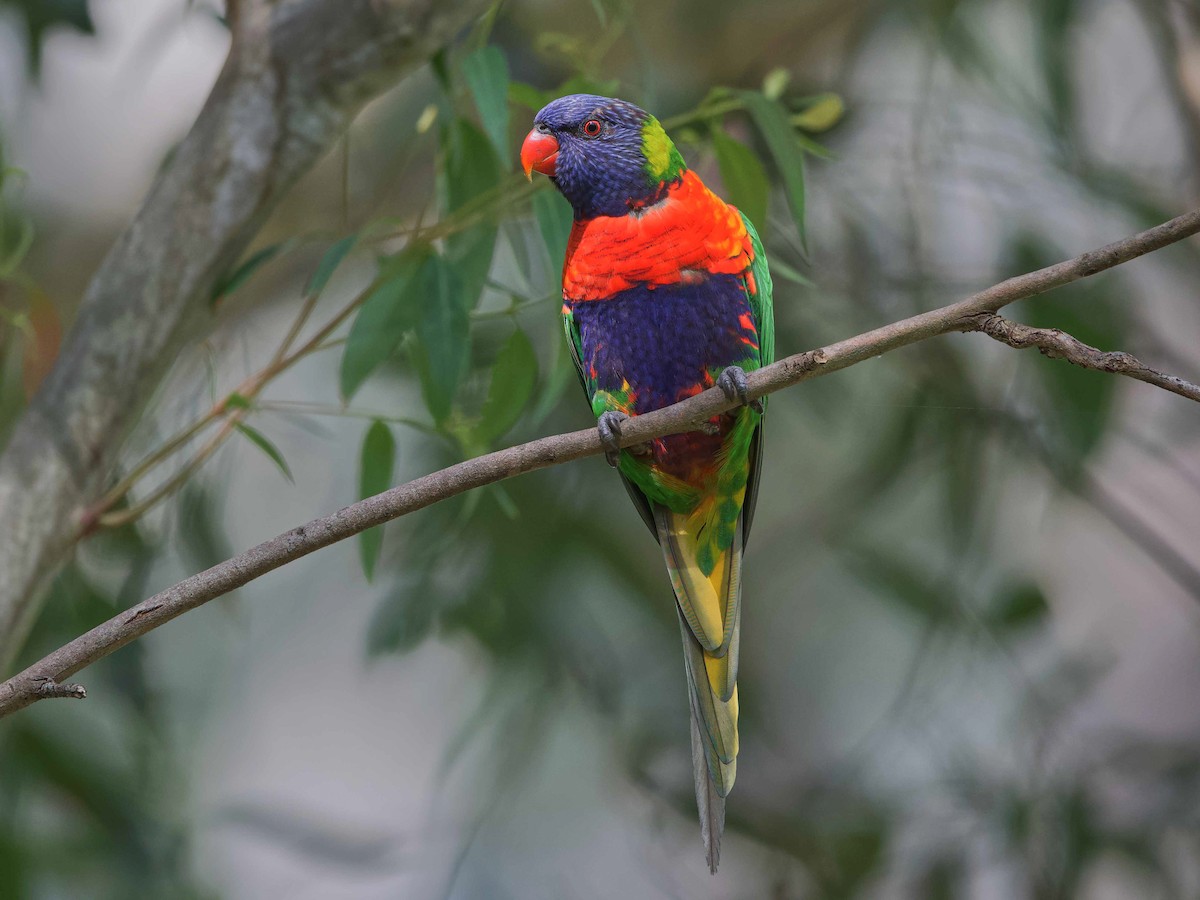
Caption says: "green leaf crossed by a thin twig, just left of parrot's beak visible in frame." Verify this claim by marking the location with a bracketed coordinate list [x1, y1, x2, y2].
[443, 119, 500, 310]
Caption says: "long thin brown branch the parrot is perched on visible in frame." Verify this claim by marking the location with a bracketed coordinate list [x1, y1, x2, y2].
[0, 210, 1200, 718]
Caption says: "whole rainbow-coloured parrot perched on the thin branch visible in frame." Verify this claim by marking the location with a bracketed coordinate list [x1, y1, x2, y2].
[521, 94, 774, 875]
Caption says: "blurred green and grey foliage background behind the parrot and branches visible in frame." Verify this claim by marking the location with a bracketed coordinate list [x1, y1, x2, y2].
[0, 0, 1200, 900]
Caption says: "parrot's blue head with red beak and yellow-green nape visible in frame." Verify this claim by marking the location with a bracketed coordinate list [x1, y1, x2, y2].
[521, 94, 686, 218]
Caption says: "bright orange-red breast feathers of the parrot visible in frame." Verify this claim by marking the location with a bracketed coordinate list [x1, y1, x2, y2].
[563, 172, 752, 301]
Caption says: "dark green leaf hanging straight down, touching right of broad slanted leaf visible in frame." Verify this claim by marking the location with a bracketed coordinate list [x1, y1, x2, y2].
[416, 256, 470, 425]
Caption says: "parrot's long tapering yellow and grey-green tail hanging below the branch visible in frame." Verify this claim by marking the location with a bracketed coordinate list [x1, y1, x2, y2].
[654, 508, 742, 874]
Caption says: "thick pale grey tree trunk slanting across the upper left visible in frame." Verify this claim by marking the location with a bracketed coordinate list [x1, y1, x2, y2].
[0, 0, 486, 671]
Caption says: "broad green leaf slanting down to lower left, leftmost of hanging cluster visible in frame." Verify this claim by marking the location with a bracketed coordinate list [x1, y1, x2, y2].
[341, 247, 430, 400]
